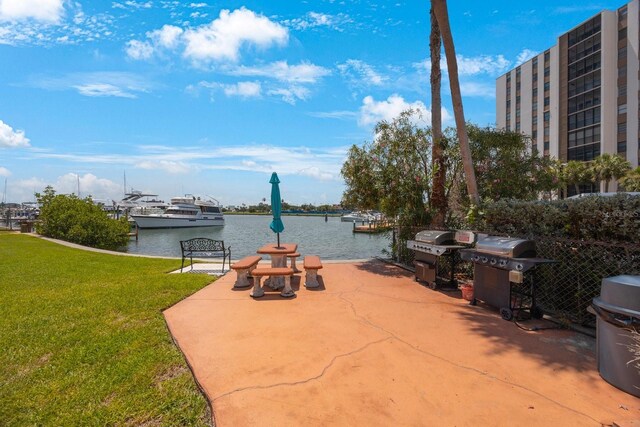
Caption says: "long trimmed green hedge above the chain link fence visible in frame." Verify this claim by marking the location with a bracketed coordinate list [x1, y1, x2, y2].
[475, 194, 640, 243]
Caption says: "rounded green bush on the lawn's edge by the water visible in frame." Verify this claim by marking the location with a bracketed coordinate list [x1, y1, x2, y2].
[36, 186, 129, 249]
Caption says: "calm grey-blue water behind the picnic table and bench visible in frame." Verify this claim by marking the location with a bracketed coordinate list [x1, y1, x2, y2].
[127, 215, 390, 259]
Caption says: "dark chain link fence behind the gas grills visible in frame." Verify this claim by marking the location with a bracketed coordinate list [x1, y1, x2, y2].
[392, 227, 640, 327]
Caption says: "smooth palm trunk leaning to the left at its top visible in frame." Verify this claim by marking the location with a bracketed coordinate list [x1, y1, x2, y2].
[431, 0, 480, 206]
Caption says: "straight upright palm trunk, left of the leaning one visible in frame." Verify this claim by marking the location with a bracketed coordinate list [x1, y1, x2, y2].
[429, 9, 447, 227]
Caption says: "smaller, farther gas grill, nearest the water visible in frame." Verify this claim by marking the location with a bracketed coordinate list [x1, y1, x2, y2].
[407, 230, 475, 289]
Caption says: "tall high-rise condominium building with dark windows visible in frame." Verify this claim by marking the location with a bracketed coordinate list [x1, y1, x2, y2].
[496, 0, 640, 191]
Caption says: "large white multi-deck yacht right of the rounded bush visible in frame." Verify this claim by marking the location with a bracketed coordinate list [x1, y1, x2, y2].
[131, 194, 224, 228]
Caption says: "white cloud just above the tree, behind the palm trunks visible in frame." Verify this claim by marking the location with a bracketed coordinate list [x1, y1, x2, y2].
[358, 94, 451, 126]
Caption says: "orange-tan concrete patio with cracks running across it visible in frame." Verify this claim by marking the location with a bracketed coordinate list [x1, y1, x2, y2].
[164, 261, 640, 427]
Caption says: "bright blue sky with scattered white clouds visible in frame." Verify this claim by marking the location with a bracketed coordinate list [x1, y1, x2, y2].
[0, 0, 623, 205]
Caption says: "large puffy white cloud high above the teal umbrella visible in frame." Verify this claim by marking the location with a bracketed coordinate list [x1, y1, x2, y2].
[184, 7, 289, 63]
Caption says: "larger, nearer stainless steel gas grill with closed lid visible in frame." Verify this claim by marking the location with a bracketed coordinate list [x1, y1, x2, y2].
[460, 236, 555, 320]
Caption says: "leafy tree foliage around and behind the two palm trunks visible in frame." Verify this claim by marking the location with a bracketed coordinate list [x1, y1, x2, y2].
[342, 111, 558, 225]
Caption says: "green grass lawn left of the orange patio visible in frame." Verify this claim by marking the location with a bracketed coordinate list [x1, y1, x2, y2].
[0, 236, 211, 426]
